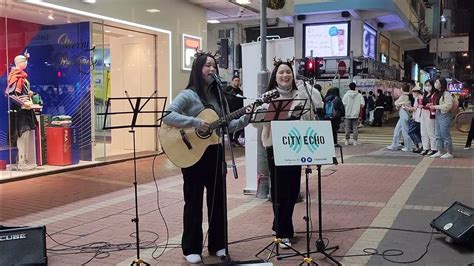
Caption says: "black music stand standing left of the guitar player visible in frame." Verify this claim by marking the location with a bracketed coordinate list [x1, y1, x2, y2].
[98, 91, 169, 265]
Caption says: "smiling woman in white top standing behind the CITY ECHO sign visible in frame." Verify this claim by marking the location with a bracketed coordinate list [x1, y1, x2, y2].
[253, 60, 322, 248]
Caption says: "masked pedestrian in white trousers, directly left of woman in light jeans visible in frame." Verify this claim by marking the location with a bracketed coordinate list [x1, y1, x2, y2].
[420, 79, 438, 156]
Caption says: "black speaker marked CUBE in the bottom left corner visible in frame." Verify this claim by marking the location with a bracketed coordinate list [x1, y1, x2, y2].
[0, 226, 48, 265]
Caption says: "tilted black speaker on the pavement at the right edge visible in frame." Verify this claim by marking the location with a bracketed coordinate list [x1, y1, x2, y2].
[430, 201, 474, 245]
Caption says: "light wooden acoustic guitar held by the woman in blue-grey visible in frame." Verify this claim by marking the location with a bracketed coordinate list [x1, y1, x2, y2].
[158, 90, 280, 168]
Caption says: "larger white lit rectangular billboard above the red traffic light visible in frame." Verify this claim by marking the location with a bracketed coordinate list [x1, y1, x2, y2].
[303, 22, 349, 57]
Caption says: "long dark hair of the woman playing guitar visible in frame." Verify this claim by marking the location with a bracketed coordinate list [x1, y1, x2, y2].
[186, 53, 219, 103]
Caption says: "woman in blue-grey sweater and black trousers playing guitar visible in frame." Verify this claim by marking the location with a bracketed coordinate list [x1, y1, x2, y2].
[163, 53, 251, 263]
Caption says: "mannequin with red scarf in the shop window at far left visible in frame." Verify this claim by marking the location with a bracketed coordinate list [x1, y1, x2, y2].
[5, 52, 38, 170]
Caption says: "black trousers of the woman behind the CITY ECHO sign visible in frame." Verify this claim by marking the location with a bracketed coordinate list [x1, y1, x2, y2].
[267, 147, 301, 238]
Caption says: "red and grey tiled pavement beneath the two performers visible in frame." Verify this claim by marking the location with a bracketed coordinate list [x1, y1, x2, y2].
[0, 135, 474, 265]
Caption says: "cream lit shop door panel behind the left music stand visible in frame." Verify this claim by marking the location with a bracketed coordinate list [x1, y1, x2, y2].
[109, 32, 156, 155]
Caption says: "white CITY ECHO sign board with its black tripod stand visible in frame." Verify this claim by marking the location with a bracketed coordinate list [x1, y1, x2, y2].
[266, 121, 341, 265]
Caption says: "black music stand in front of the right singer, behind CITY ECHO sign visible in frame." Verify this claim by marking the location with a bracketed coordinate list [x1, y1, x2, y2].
[250, 99, 310, 261]
